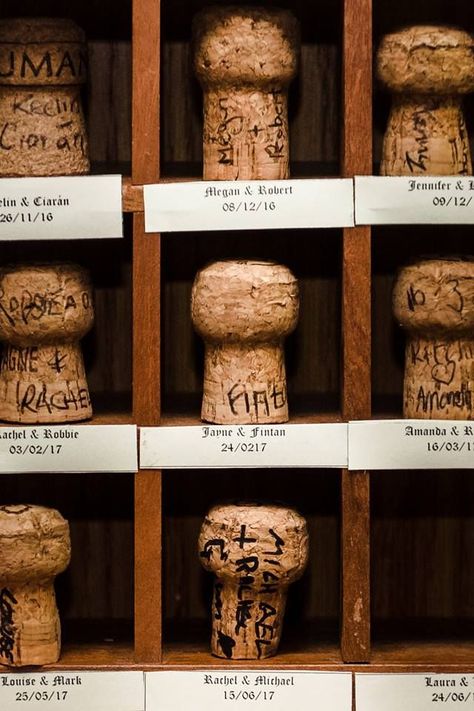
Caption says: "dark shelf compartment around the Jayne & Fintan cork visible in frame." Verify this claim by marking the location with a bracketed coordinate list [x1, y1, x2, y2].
[162, 230, 341, 424]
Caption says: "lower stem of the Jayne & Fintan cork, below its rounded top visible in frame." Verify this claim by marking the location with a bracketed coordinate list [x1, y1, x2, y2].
[201, 341, 288, 424]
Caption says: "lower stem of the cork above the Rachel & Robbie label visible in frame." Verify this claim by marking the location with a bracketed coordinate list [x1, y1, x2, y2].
[0, 342, 92, 423]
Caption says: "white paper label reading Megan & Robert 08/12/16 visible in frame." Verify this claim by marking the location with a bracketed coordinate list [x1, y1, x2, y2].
[144, 179, 354, 232]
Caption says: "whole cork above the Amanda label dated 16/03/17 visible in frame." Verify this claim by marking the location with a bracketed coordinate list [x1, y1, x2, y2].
[393, 259, 474, 420]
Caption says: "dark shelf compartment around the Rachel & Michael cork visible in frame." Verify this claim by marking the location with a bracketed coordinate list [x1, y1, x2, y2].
[163, 469, 340, 663]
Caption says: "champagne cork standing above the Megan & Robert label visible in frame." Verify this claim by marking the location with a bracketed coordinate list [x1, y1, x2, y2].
[193, 7, 299, 180]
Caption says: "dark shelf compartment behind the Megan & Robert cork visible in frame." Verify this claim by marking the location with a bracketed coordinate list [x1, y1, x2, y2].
[161, 0, 342, 179]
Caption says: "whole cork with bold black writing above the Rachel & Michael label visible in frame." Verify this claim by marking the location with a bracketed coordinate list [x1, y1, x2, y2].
[199, 503, 308, 659]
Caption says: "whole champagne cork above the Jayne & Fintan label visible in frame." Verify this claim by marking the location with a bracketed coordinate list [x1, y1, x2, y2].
[191, 260, 299, 424]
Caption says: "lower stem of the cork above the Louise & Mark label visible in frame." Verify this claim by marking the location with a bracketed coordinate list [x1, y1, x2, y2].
[0, 579, 61, 666]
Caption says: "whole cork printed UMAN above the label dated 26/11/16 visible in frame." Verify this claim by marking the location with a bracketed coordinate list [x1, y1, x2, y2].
[0, 18, 90, 177]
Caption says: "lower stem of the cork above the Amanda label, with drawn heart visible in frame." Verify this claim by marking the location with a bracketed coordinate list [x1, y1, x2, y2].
[403, 333, 474, 420]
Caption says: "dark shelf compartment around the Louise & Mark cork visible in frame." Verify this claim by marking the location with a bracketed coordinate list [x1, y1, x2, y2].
[1, 473, 134, 668]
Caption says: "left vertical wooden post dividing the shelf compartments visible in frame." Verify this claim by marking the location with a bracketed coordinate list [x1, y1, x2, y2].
[132, 0, 162, 663]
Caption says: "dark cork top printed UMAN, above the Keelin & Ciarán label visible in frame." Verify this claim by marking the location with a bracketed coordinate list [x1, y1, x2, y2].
[0, 17, 87, 86]
